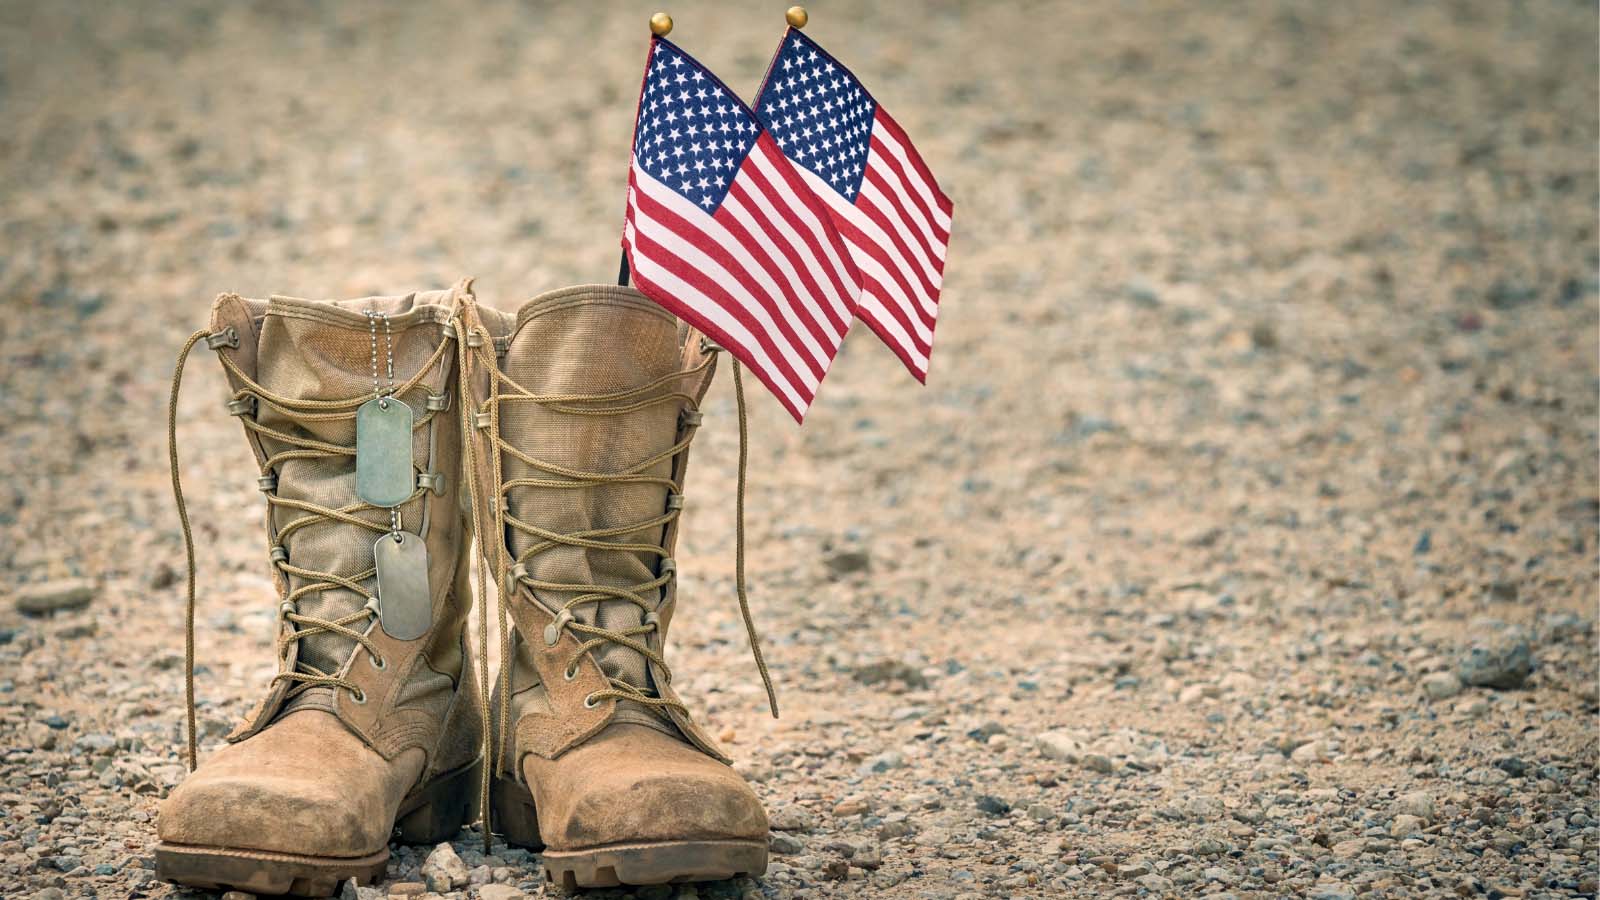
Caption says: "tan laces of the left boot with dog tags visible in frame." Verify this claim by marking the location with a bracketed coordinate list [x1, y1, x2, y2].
[166, 330, 446, 770]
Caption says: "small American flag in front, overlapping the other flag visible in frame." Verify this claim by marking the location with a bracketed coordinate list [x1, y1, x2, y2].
[622, 37, 861, 421]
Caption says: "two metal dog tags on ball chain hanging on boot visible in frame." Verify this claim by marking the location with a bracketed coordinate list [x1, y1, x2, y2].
[355, 311, 434, 641]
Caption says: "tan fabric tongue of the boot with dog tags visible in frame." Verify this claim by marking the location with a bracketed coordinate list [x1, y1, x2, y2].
[256, 291, 450, 698]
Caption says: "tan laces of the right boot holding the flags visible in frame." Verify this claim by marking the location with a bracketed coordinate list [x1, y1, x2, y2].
[456, 319, 778, 797]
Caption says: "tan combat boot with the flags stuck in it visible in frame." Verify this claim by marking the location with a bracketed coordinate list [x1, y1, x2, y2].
[464, 285, 768, 889]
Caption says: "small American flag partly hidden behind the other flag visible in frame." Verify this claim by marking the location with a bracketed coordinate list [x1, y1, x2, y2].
[755, 29, 954, 383]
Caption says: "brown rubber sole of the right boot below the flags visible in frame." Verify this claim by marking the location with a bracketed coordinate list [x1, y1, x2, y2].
[493, 778, 766, 890]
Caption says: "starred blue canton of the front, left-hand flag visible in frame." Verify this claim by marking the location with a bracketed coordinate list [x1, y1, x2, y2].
[634, 40, 762, 213]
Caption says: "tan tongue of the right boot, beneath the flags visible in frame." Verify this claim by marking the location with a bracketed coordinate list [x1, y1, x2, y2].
[501, 285, 682, 692]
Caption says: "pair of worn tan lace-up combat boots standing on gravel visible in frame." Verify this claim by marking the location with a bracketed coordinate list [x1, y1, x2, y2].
[155, 280, 768, 895]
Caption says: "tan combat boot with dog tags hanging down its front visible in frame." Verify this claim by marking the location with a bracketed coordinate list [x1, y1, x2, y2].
[155, 282, 483, 895]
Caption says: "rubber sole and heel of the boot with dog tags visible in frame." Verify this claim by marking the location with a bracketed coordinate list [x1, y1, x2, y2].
[155, 752, 480, 897]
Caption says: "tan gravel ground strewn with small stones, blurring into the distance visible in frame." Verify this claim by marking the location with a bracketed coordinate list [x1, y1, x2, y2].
[0, 0, 1600, 900]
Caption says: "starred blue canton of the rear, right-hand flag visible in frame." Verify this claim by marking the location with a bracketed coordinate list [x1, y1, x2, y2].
[755, 30, 874, 200]
